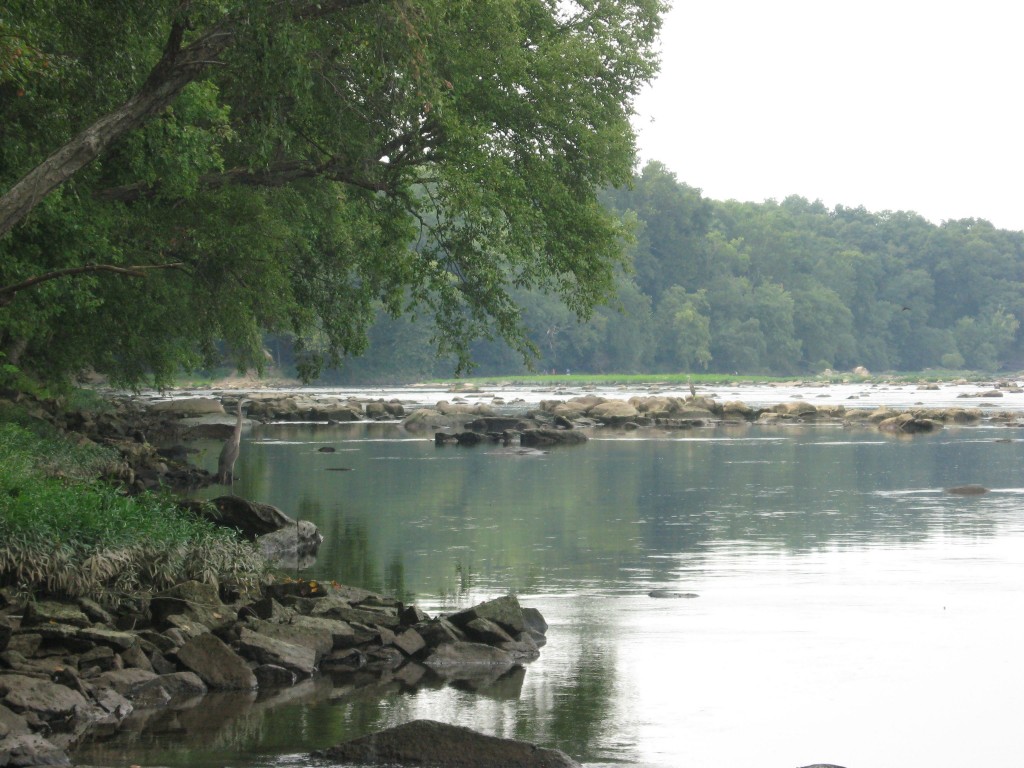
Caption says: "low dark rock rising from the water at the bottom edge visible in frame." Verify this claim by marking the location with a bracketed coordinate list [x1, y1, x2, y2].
[314, 720, 580, 768]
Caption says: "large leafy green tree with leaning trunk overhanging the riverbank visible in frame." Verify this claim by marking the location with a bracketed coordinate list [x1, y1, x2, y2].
[0, 0, 664, 383]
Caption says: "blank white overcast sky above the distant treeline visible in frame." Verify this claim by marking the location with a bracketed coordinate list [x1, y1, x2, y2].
[636, 0, 1024, 229]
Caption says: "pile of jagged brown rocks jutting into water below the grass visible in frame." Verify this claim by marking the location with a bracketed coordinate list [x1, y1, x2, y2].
[0, 581, 548, 766]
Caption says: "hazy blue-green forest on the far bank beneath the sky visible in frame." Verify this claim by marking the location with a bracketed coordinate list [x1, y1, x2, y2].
[307, 163, 1024, 383]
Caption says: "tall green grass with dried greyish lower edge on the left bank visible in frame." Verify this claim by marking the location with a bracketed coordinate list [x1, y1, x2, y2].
[0, 424, 265, 605]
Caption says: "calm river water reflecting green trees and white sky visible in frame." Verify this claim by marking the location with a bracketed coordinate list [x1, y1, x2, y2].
[76, 390, 1024, 768]
